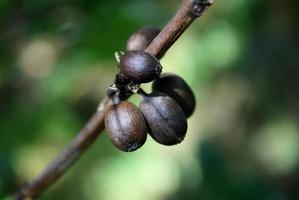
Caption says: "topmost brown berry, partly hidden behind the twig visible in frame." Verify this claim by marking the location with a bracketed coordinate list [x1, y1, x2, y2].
[126, 26, 161, 51]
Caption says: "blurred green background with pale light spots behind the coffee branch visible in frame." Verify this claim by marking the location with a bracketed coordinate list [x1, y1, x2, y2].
[0, 0, 299, 200]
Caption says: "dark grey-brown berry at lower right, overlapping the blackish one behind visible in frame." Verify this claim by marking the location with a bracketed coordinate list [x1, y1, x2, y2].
[139, 92, 187, 145]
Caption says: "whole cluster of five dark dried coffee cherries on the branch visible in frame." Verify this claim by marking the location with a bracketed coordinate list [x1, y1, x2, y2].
[105, 26, 195, 152]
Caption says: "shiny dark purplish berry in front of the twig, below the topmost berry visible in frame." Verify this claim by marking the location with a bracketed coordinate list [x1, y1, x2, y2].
[119, 51, 162, 83]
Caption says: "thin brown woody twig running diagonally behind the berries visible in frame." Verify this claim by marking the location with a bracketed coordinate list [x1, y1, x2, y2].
[15, 0, 213, 200]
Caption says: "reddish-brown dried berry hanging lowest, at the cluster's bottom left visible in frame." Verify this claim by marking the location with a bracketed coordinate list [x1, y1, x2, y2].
[105, 101, 147, 152]
